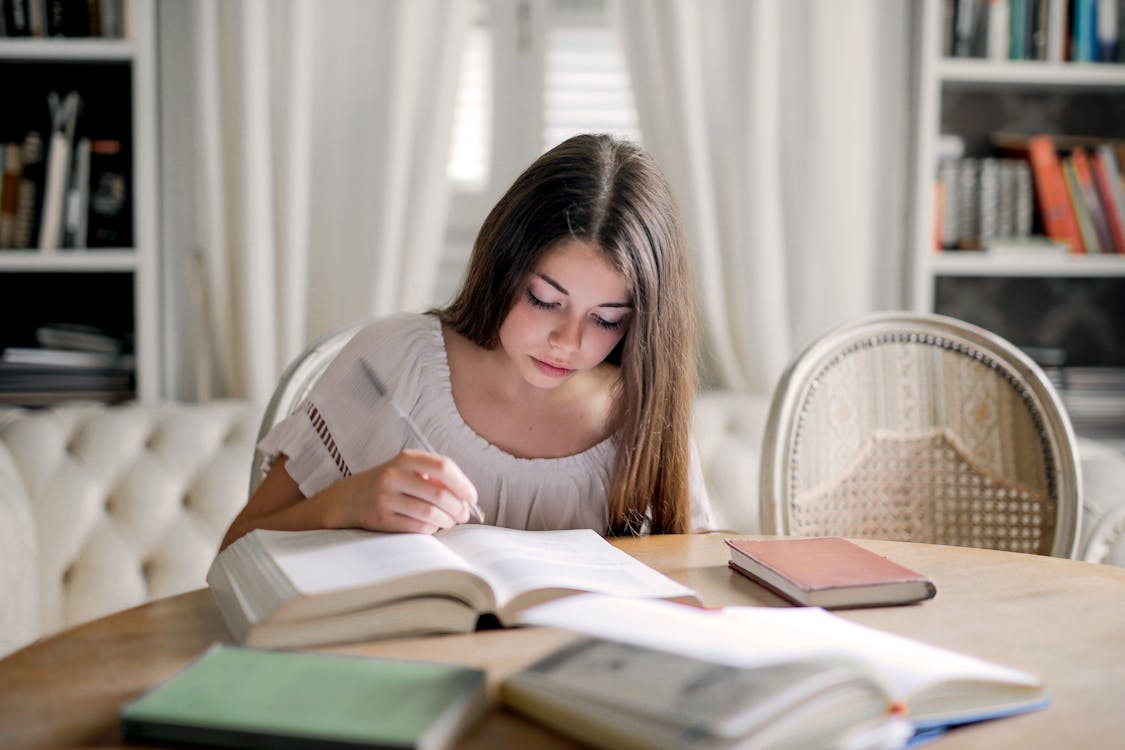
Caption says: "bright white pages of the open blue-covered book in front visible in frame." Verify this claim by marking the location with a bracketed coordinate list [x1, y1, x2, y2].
[520, 596, 1041, 701]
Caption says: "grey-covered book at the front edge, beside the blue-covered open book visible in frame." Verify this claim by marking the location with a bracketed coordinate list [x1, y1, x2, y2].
[501, 638, 891, 750]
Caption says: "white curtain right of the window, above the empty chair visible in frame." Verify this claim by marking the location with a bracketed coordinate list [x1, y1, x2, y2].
[615, 0, 909, 394]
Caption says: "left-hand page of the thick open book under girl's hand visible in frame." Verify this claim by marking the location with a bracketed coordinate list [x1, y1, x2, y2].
[259, 530, 471, 594]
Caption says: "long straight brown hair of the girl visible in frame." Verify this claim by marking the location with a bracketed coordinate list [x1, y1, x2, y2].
[435, 135, 695, 535]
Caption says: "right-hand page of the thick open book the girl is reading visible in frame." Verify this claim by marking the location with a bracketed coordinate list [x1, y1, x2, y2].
[437, 525, 694, 608]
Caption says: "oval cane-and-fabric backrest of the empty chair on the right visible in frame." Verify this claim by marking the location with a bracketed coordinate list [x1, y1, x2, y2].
[759, 313, 1081, 557]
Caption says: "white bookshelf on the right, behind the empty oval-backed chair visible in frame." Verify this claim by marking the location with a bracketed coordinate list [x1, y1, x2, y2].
[908, 0, 1125, 439]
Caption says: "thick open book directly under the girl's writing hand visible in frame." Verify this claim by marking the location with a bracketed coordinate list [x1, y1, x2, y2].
[207, 525, 698, 648]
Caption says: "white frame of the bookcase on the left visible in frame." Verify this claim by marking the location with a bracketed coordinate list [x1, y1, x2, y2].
[0, 0, 162, 400]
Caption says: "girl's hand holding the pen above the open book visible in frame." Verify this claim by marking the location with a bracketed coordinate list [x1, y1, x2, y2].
[332, 450, 477, 534]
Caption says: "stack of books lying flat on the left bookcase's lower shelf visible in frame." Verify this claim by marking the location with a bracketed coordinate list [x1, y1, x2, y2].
[0, 324, 136, 406]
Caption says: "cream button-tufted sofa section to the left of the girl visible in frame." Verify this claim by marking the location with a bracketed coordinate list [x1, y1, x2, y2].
[0, 401, 258, 653]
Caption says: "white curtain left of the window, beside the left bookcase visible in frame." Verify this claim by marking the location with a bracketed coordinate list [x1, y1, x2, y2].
[161, 0, 471, 403]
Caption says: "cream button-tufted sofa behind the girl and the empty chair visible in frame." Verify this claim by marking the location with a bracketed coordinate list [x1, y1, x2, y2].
[0, 391, 1125, 656]
